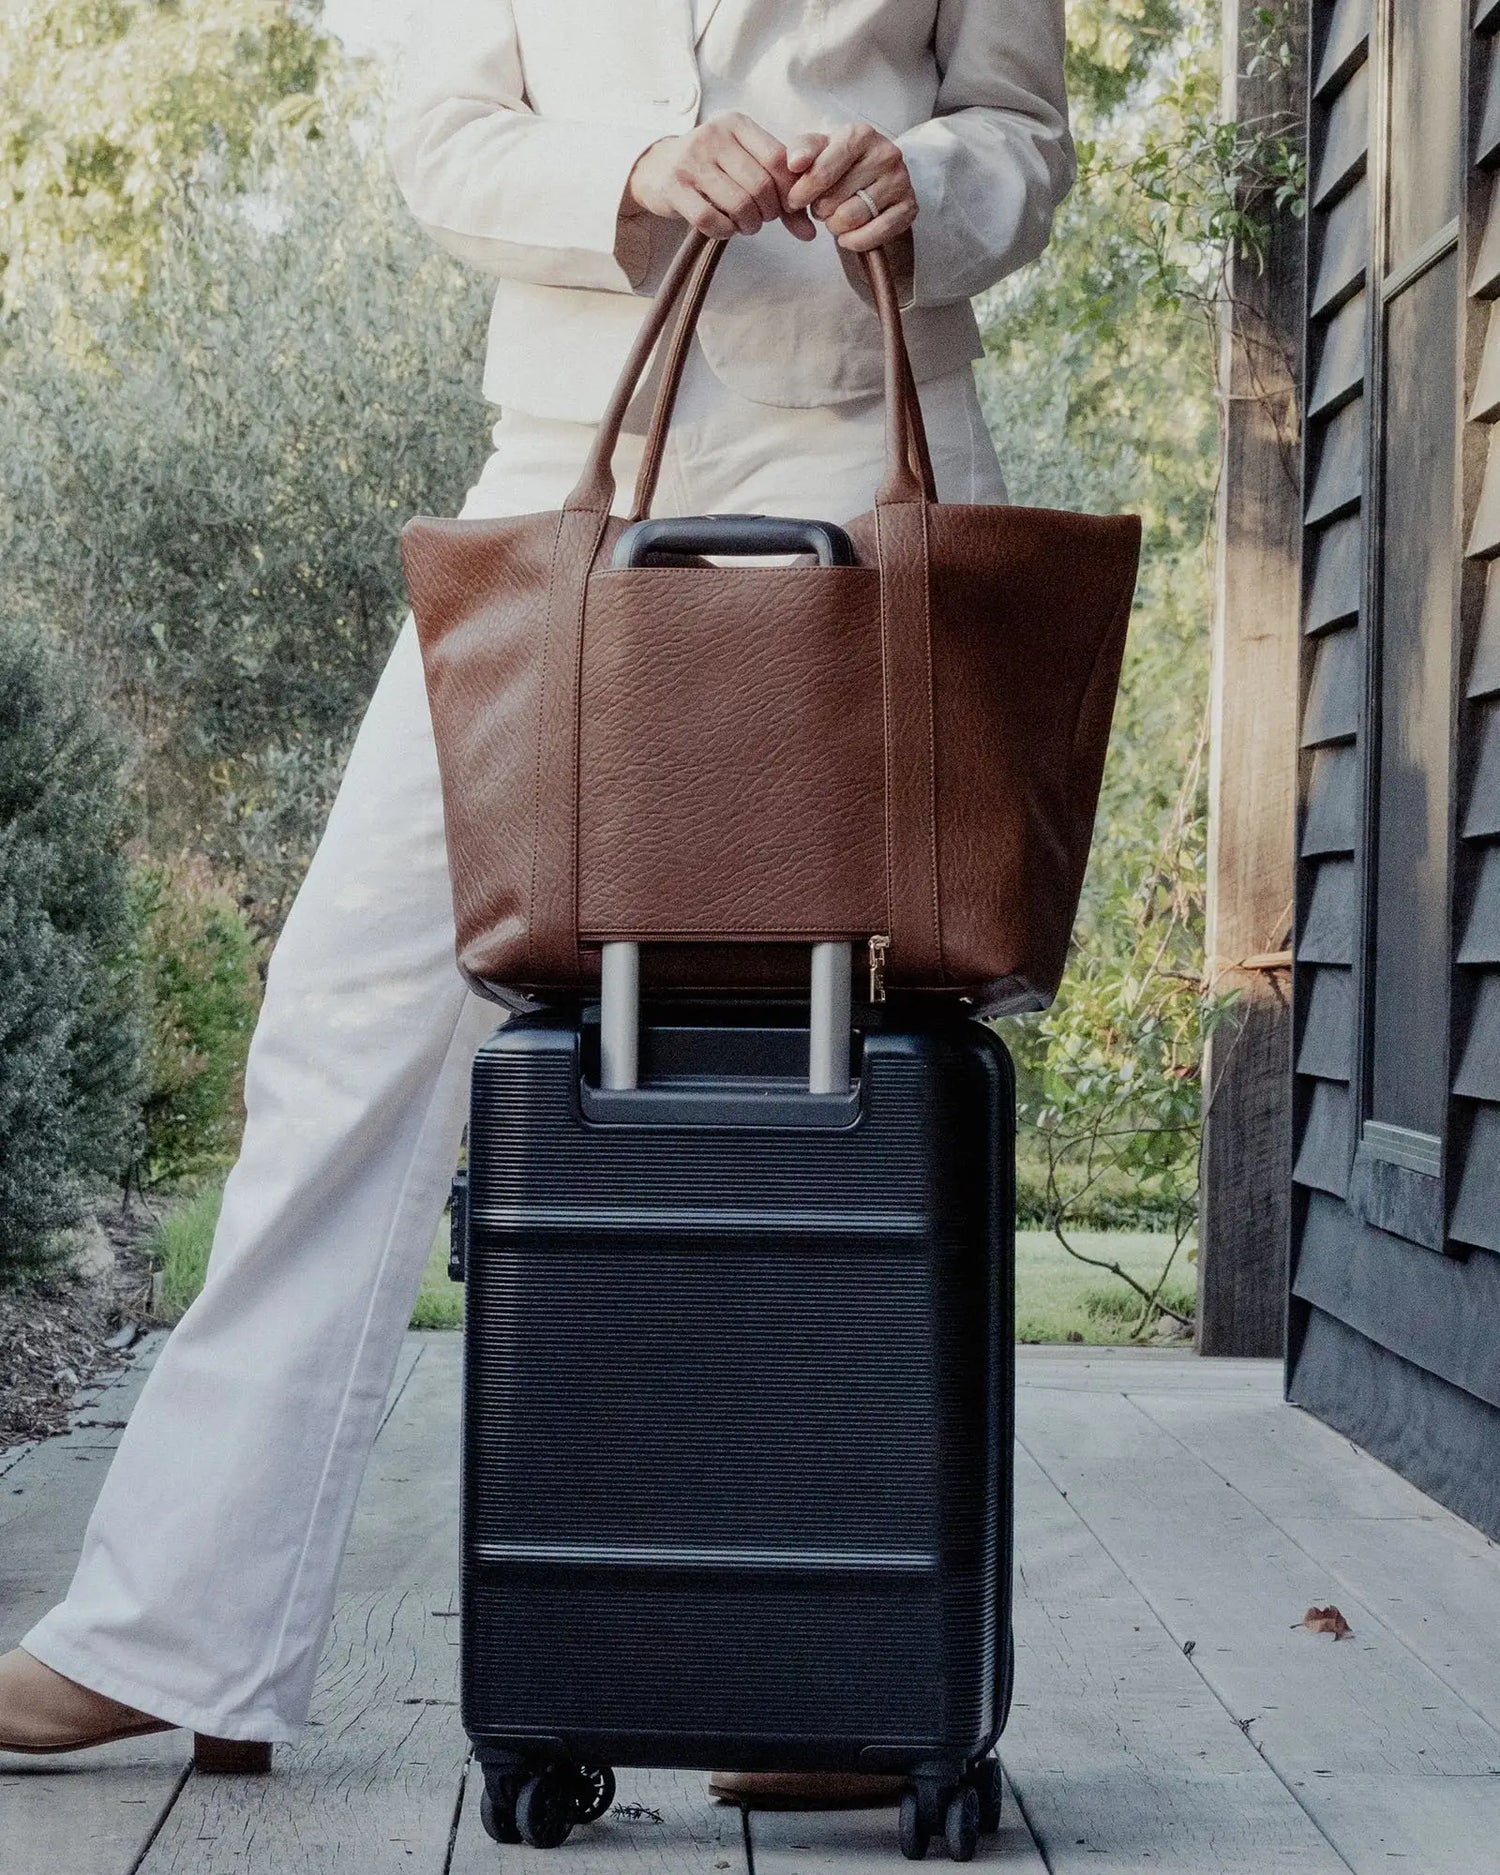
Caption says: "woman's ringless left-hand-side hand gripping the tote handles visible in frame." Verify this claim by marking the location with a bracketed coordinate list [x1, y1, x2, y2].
[624, 111, 818, 240]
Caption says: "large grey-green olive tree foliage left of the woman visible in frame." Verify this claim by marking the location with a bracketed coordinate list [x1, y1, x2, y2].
[0, 81, 486, 932]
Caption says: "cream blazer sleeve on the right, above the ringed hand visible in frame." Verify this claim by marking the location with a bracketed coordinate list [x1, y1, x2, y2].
[896, 0, 1078, 306]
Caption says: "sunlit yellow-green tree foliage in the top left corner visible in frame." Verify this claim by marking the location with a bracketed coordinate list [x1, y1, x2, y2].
[0, 0, 330, 306]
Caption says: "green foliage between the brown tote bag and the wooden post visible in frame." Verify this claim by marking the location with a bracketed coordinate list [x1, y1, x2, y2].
[981, 0, 1303, 1331]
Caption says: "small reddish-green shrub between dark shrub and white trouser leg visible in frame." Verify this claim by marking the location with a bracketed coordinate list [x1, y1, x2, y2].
[133, 859, 261, 1185]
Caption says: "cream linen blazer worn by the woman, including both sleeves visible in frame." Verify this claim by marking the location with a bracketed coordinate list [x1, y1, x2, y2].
[388, 0, 1074, 422]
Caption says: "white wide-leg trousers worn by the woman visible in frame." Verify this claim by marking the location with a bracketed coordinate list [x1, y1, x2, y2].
[23, 353, 1005, 1742]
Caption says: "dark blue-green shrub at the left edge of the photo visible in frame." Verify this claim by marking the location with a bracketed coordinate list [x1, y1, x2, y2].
[0, 621, 143, 1283]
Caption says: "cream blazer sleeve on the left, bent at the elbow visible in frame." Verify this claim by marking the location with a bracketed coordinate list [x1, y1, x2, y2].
[386, 0, 654, 293]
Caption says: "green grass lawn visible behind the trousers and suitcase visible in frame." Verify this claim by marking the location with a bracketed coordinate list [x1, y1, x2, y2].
[152, 1185, 1194, 1346]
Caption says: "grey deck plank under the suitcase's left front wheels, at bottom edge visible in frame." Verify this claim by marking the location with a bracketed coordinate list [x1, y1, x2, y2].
[450, 1764, 750, 1875]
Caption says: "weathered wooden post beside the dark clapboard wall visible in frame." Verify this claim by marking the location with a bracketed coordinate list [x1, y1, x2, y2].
[1196, 0, 1309, 1356]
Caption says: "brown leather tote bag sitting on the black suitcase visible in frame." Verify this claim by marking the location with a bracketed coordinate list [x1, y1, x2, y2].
[403, 234, 1140, 1011]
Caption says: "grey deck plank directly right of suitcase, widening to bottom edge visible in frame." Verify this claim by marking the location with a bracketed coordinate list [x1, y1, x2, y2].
[1001, 1440, 1346, 1875]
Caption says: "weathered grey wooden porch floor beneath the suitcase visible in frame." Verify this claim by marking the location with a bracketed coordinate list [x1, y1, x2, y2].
[0, 1335, 1500, 1875]
